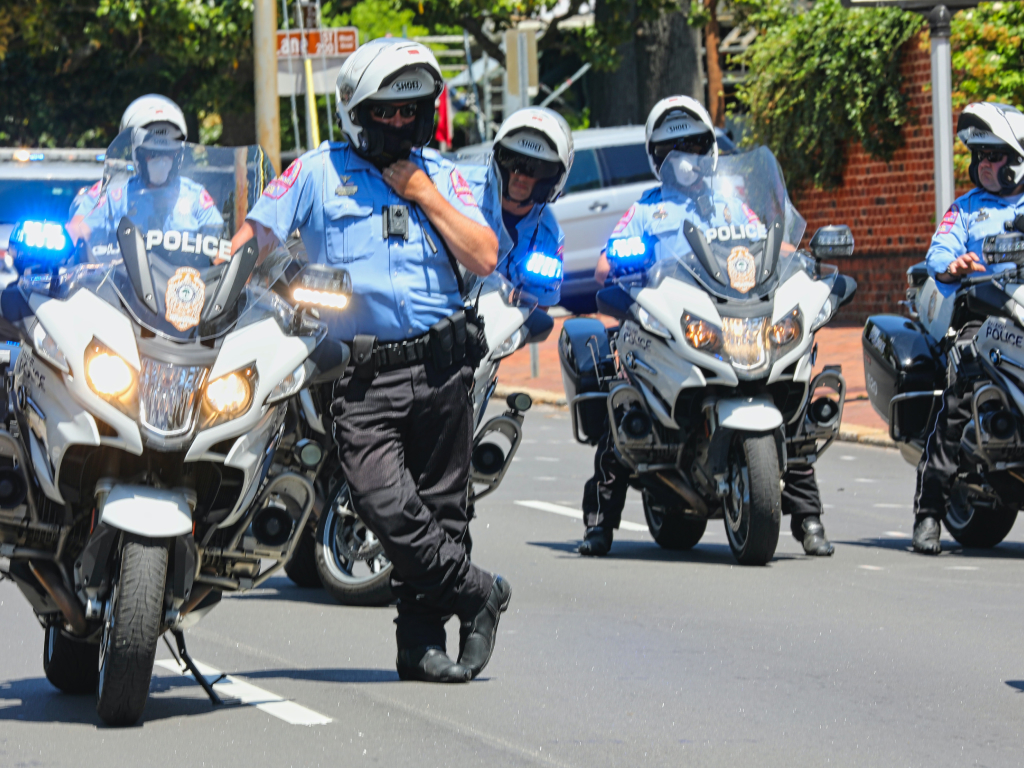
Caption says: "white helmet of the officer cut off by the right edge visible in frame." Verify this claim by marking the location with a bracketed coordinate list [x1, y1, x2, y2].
[956, 101, 1024, 195]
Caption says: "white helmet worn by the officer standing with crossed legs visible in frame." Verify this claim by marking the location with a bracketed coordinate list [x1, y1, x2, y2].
[335, 38, 444, 161]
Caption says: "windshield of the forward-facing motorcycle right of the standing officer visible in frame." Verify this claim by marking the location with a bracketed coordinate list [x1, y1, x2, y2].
[647, 146, 807, 302]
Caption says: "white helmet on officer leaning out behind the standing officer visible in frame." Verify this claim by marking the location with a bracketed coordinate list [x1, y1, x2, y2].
[492, 106, 573, 203]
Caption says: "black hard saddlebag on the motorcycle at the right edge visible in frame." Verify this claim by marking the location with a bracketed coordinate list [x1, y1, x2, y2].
[861, 314, 946, 442]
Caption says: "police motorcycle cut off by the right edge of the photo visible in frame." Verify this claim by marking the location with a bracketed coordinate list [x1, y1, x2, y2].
[861, 216, 1024, 548]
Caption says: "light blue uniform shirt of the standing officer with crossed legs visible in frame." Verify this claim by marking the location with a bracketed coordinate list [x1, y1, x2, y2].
[248, 142, 486, 341]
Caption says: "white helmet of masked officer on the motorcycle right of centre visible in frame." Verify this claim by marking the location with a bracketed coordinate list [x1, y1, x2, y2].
[644, 96, 718, 187]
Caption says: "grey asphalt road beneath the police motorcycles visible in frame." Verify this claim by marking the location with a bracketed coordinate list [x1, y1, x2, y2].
[0, 407, 1024, 768]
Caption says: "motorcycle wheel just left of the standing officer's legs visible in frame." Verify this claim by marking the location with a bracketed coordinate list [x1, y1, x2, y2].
[316, 482, 394, 605]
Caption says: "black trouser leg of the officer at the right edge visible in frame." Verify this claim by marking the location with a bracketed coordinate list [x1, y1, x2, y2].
[913, 322, 981, 520]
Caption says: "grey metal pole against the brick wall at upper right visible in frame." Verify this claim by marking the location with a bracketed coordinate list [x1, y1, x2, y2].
[928, 5, 954, 223]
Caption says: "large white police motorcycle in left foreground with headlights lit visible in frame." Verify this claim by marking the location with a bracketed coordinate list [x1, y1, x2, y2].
[0, 132, 350, 725]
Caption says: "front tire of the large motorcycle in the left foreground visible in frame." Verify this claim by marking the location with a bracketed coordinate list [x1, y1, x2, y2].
[96, 534, 167, 726]
